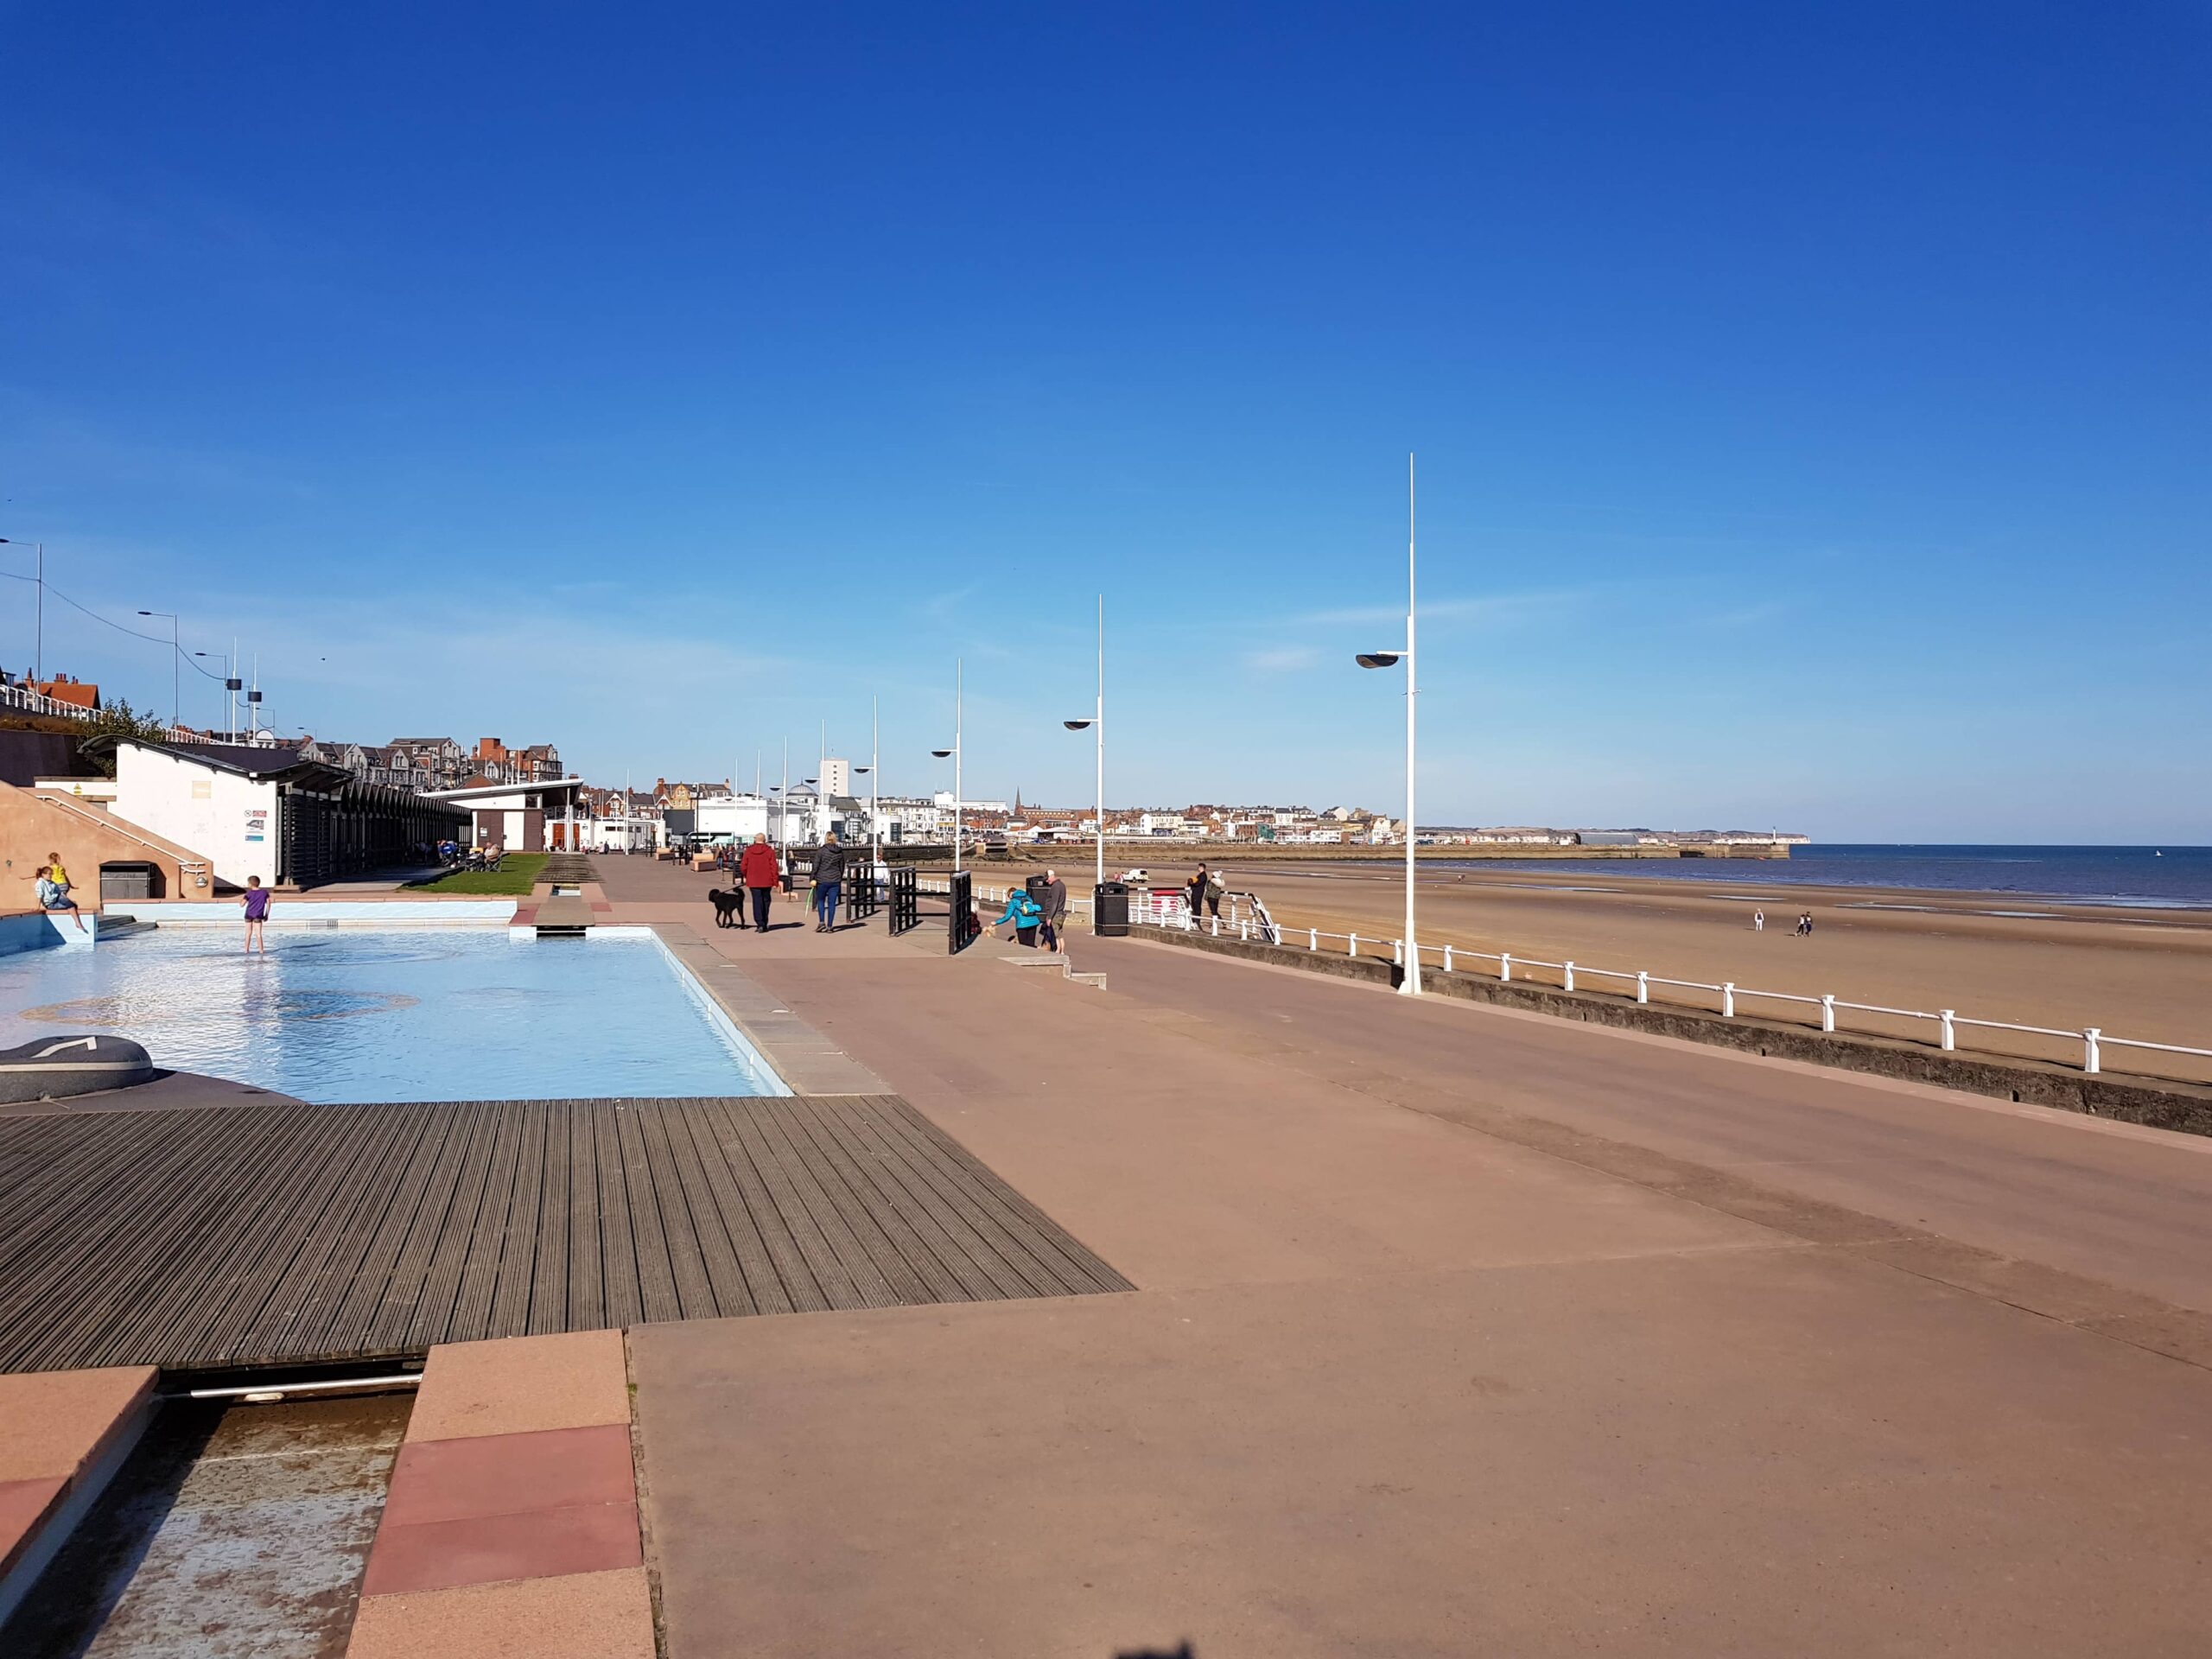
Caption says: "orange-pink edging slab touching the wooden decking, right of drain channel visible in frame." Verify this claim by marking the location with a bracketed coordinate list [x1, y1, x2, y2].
[407, 1332, 631, 1442]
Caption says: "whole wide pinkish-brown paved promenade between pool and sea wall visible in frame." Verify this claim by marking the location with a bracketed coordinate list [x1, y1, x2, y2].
[600, 861, 2212, 1659]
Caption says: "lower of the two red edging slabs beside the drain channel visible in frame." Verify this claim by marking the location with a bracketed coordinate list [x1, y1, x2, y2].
[360, 1502, 641, 1597]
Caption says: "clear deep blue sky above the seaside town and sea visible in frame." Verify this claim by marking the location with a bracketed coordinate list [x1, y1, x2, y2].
[0, 3, 2212, 842]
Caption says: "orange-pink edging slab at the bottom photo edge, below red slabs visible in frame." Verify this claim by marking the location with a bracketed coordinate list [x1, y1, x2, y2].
[345, 1566, 655, 1659]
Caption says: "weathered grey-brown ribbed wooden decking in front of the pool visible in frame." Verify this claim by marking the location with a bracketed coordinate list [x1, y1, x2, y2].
[0, 1095, 1128, 1371]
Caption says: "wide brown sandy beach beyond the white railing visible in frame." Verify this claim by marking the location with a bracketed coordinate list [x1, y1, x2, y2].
[1000, 856, 2212, 1082]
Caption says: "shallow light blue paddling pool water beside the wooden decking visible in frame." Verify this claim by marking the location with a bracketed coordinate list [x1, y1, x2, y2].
[0, 927, 790, 1102]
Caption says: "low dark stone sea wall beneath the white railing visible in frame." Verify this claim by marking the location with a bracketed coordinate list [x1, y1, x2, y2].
[1133, 927, 2212, 1135]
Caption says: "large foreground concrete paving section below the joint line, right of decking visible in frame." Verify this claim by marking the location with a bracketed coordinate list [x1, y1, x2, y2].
[632, 1248, 2212, 1659]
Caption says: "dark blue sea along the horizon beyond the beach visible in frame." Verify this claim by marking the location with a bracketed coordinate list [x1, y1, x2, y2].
[1422, 845, 2212, 909]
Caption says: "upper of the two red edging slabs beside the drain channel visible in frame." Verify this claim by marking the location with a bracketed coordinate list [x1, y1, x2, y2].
[383, 1422, 637, 1529]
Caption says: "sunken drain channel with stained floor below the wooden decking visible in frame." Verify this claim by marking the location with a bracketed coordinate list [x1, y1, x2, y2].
[0, 1370, 420, 1659]
